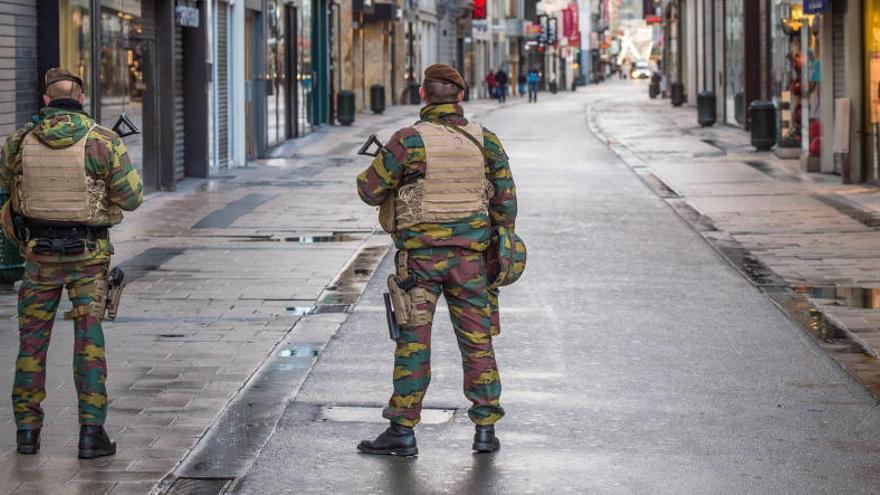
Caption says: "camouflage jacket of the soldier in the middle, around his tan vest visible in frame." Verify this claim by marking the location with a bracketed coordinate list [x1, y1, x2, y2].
[357, 104, 516, 251]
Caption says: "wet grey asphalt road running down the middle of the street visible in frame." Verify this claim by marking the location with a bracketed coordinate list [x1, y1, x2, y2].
[229, 87, 880, 494]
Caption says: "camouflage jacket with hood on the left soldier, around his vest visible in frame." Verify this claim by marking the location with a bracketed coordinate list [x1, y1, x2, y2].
[0, 107, 144, 263]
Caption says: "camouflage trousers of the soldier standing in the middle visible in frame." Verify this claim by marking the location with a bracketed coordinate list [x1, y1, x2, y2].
[383, 248, 504, 427]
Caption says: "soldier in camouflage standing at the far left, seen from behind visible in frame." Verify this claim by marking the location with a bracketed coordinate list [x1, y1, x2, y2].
[0, 69, 143, 458]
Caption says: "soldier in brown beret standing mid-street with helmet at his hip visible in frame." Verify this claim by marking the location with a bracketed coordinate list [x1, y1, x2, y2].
[357, 65, 516, 455]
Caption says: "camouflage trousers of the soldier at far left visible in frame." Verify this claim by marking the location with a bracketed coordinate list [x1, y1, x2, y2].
[12, 262, 107, 429]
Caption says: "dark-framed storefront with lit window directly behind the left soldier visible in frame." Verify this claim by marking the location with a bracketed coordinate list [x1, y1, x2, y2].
[49, 0, 209, 190]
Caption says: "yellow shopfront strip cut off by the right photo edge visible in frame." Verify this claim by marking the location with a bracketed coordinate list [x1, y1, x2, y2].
[863, 0, 880, 183]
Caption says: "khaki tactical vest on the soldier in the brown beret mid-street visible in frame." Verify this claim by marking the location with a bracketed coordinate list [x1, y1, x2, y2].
[394, 122, 492, 229]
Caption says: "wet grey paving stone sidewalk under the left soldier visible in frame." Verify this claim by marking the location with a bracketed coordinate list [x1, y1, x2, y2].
[0, 102, 508, 494]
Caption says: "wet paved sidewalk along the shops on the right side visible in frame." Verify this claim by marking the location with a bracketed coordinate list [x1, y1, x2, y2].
[588, 83, 880, 380]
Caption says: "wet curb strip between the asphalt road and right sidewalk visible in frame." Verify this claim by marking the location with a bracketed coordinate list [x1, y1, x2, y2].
[586, 103, 880, 403]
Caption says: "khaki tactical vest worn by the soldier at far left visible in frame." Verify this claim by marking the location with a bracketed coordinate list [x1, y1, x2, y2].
[13, 125, 122, 226]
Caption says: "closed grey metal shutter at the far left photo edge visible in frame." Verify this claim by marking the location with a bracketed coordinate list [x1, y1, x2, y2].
[0, 0, 39, 139]
